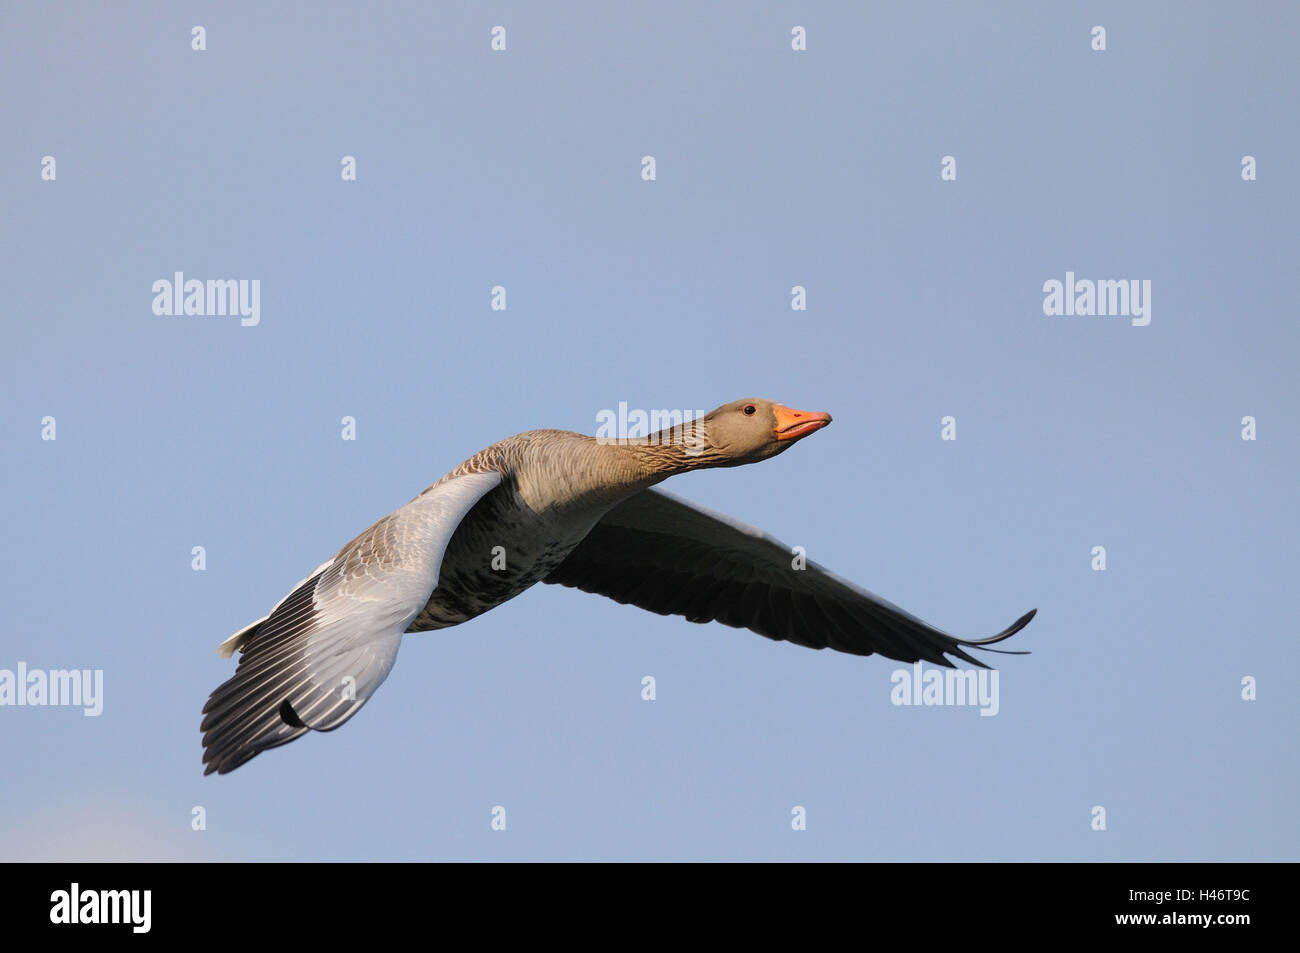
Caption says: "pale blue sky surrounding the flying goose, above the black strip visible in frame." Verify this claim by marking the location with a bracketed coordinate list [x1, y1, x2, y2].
[0, 3, 1300, 861]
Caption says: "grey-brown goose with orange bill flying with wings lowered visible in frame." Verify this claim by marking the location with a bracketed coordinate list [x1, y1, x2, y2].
[202, 399, 1037, 774]
